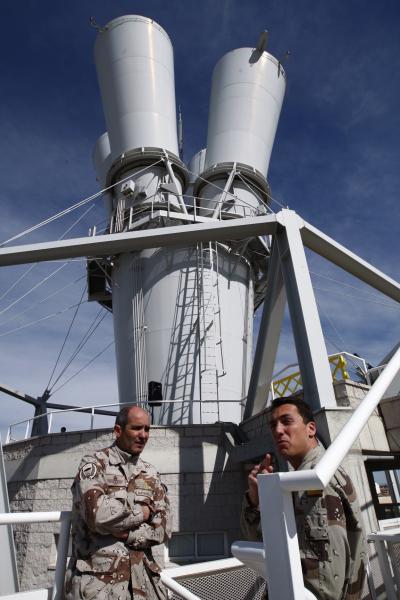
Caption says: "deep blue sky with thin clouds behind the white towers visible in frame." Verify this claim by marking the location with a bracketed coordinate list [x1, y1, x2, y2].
[0, 0, 400, 438]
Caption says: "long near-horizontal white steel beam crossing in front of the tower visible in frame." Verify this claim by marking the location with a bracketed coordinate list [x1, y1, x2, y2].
[0, 214, 277, 267]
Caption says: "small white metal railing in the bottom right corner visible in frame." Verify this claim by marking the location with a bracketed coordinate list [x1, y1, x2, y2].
[367, 528, 400, 600]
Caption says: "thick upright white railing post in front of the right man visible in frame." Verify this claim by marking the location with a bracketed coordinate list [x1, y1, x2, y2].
[258, 473, 305, 600]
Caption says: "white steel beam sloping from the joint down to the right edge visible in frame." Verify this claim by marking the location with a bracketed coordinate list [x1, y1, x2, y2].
[300, 221, 400, 302]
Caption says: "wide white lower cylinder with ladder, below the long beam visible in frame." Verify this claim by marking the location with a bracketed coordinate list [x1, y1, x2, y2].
[113, 244, 254, 424]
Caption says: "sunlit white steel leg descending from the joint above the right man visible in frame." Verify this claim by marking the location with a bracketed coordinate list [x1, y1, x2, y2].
[276, 209, 336, 410]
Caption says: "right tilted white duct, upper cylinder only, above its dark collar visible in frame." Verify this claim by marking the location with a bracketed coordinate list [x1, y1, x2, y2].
[205, 48, 285, 177]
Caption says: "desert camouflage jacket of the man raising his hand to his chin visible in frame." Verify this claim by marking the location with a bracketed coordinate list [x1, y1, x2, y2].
[241, 446, 366, 600]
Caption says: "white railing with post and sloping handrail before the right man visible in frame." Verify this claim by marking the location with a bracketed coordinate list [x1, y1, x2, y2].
[258, 348, 400, 600]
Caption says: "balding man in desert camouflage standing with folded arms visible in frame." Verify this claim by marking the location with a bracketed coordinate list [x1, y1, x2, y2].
[65, 406, 170, 600]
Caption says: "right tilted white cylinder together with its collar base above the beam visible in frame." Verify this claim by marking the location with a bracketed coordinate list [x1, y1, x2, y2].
[195, 48, 286, 218]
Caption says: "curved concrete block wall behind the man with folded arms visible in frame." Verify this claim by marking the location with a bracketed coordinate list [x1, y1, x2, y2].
[4, 424, 245, 590]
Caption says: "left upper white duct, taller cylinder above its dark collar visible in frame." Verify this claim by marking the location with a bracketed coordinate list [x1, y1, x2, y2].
[95, 15, 178, 160]
